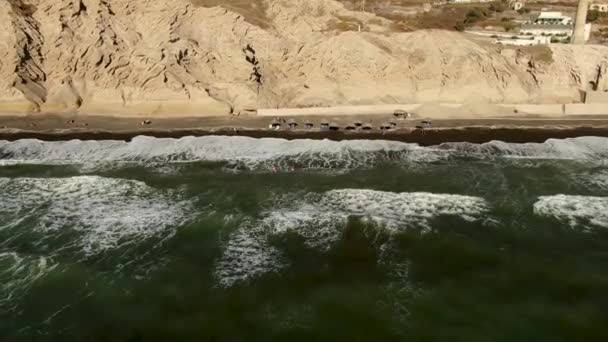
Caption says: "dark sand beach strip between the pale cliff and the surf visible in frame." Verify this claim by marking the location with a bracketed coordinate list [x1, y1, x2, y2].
[0, 115, 608, 145]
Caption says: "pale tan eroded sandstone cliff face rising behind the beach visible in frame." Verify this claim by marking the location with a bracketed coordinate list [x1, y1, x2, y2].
[0, 0, 608, 115]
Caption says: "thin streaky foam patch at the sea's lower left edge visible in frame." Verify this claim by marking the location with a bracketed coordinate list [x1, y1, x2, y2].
[0, 252, 57, 311]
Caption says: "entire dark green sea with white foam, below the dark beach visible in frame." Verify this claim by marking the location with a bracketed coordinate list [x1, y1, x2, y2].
[0, 137, 608, 342]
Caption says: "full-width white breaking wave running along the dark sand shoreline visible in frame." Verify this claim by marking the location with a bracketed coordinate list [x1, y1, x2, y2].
[0, 136, 608, 170]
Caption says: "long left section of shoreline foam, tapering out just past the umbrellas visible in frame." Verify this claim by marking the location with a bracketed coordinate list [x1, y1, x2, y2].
[0, 136, 437, 169]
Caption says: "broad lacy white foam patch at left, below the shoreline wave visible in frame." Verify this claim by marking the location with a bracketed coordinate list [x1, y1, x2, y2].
[0, 176, 191, 256]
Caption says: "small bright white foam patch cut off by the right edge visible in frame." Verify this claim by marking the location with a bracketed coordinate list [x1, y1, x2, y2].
[534, 195, 608, 231]
